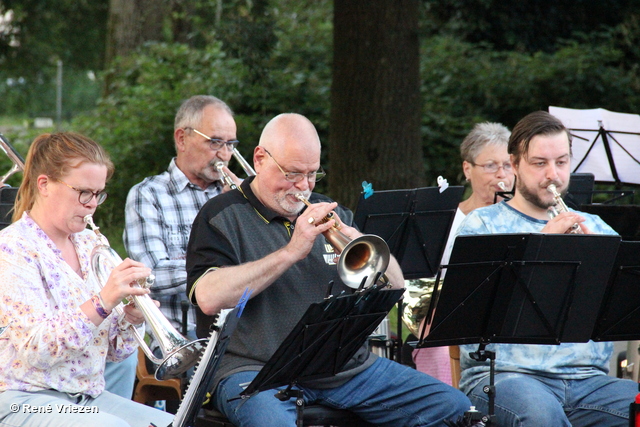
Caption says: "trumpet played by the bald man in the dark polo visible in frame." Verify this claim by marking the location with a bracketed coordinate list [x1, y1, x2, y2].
[296, 193, 391, 289]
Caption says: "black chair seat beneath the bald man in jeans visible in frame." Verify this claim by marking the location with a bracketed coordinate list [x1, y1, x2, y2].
[195, 405, 375, 427]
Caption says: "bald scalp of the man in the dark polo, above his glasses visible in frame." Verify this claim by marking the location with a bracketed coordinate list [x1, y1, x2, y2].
[259, 113, 320, 158]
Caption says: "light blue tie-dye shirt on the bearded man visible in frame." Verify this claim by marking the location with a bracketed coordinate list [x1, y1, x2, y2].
[458, 202, 617, 392]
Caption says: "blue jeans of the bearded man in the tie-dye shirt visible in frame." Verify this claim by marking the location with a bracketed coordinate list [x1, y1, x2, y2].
[468, 373, 638, 427]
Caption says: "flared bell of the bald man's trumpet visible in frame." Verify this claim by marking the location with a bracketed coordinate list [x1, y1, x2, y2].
[338, 234, 390, 289]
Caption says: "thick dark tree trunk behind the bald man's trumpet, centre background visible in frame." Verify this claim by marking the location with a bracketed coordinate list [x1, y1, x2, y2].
[329, 0, 426, 208]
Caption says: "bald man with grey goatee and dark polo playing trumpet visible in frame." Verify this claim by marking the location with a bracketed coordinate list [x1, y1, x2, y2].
[187, 114, 470, 427]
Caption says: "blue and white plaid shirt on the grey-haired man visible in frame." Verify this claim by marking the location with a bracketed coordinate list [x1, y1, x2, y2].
[123, 158, 222, 331]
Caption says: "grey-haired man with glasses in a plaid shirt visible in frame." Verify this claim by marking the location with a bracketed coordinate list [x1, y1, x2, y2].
[123, 95, 241, 339]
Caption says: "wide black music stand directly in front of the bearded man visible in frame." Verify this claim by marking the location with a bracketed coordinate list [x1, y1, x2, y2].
[417, 234, 620, 421]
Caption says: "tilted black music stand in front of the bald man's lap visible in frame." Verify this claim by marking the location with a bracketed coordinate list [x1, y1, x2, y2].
[240, 286, 404, 425]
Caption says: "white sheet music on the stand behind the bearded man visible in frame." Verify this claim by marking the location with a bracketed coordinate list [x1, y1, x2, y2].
[549, 107, 640, 184]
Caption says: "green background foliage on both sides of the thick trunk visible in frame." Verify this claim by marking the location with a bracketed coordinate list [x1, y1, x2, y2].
[5, 0, 640, 251]
